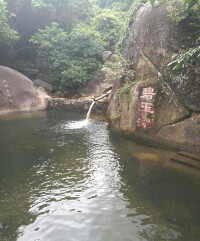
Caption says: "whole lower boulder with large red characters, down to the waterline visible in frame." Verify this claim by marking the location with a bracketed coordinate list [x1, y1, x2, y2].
[108, 77, 200, 154]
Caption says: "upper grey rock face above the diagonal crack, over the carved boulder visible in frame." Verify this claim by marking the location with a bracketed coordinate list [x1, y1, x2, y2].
[125, 3, 200, 111]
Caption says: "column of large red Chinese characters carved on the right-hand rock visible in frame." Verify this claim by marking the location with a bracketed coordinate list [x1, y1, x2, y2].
[137, 87, 156, 129]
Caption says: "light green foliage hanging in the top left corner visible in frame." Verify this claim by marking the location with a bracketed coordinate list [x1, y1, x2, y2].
[0, 0, 19, 45]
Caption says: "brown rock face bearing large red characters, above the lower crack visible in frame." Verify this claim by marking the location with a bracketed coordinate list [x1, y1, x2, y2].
[108, 78, 189, 138]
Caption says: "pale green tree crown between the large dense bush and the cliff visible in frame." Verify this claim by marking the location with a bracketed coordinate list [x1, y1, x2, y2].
[92, 9, 123, 50]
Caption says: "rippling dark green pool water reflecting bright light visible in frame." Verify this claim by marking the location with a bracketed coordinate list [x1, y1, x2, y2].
[0, 112, 200, 241]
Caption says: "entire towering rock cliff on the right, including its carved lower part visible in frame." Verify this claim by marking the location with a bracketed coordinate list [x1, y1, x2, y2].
[108, 3, 200, 153]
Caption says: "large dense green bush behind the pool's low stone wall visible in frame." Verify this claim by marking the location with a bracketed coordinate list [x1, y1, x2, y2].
[30, 23, 103, 88]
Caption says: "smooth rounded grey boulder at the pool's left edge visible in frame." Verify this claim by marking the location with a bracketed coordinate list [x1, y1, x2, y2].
[0, 66, 47, 114]
